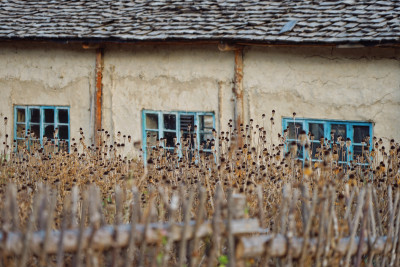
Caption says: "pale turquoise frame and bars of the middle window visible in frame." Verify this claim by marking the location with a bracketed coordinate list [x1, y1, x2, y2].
[142, 109, 215, 159]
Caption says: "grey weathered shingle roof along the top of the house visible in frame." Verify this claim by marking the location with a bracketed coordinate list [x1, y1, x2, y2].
[0, 0, 400, 44]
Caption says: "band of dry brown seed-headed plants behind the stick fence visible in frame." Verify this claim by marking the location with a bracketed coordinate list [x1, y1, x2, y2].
[0, 114, 400, 266]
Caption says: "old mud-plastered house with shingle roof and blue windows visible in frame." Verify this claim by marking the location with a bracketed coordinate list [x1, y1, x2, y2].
[0, 0, 400, 163]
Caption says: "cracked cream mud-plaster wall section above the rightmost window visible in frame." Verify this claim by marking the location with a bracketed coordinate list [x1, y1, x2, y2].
[243, 48, 400, 144]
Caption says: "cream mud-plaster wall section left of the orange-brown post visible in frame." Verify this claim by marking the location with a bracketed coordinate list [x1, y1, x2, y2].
[0, 43, 95, 146]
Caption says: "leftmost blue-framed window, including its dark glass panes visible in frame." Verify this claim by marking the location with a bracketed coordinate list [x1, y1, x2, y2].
[14, 106, 70, 150]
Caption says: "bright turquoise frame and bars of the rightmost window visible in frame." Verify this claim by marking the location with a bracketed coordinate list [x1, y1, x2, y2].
[282, 117, 373, 164]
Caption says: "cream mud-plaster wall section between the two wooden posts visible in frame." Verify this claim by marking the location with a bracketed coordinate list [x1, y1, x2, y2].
[103, 45, 234, 155]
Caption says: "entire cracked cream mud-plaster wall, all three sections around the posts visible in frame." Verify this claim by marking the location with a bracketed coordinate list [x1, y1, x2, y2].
[0, 43, 400, 157]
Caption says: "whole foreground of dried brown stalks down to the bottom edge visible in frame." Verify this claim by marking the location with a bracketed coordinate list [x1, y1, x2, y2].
[0, 114, 400, 266]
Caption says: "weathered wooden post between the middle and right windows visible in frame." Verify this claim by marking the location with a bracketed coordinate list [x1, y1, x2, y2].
[234, 48, 244, 147]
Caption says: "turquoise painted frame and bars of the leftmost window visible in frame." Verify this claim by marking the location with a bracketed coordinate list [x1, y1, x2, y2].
[13, 105, 71, 151]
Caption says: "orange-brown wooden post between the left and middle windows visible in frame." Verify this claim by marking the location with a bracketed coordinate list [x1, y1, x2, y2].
[94, 48, 104, 146]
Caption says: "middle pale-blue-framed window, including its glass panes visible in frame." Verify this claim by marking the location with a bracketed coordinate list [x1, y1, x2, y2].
[143, 110, 215, 158]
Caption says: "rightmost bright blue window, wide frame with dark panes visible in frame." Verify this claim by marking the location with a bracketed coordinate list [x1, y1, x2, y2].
[282, 118, 373, 164]
